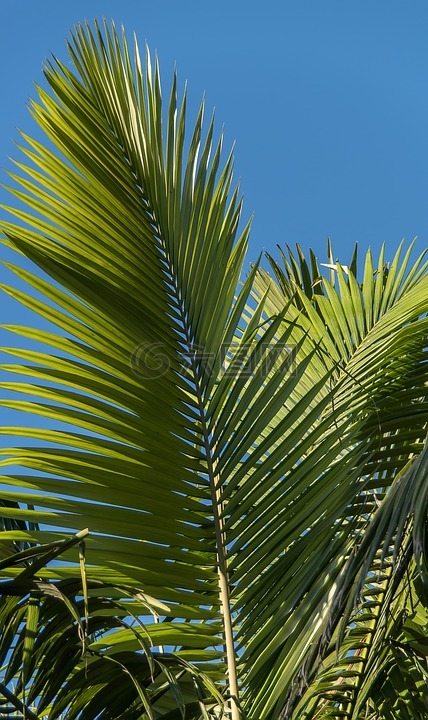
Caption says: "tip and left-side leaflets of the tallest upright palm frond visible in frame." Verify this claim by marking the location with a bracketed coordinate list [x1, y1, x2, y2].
[2, 19, 254, 716]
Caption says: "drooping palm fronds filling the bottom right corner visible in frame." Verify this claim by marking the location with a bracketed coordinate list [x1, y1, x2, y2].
[293, 448, 428, 720]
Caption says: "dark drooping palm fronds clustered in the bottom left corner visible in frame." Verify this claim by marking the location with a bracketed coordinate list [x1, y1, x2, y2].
[0, 531, 222, 720]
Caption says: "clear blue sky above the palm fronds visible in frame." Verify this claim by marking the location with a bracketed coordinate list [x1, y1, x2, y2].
[0, 0, 428, 263]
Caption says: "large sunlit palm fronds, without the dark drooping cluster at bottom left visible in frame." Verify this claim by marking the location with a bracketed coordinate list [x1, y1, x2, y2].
[1, 19, 428, 720]
